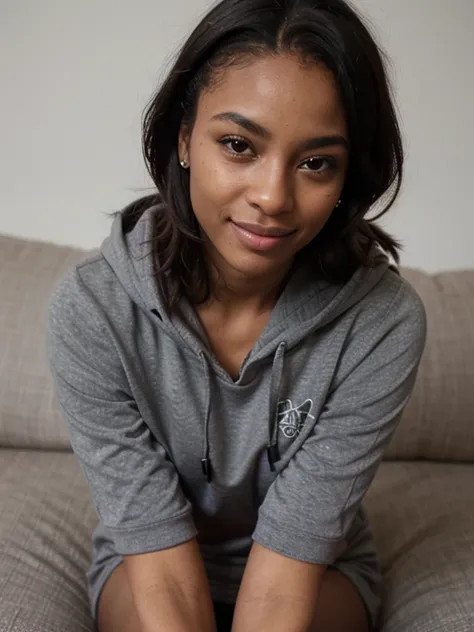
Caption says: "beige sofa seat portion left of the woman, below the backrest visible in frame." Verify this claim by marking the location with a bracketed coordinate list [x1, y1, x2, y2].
[0, 449, 98, 632]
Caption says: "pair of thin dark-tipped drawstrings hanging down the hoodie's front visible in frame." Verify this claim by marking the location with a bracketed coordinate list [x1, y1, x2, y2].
[200, 342, 286, 483]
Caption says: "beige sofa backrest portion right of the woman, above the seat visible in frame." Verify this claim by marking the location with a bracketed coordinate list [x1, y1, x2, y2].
[385, 268, 474, 462]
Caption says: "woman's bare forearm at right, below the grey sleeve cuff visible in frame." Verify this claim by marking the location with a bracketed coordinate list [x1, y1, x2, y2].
[232, 542, 326, 632]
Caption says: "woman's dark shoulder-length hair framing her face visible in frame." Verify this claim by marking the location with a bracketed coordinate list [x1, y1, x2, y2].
[122, 0, 404, 312]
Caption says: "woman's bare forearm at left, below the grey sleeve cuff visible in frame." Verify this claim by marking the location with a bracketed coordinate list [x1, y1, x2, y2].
[124, 539, 216, 632]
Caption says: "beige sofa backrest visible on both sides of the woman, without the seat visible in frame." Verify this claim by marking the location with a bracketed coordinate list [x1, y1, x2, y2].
[0, 236, 474, 461]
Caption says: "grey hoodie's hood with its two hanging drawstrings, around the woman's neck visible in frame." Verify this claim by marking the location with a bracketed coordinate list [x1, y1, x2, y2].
[101, 203, 390, 481]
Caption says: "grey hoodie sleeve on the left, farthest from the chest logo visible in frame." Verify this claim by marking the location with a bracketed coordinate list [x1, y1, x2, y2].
[47, 266, 197, 554]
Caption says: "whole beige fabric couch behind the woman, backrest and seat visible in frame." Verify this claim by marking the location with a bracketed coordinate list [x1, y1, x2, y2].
[0, 231, 474, 632]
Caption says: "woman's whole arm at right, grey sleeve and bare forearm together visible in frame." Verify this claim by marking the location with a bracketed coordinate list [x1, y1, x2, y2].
[241, 285, 426, 632]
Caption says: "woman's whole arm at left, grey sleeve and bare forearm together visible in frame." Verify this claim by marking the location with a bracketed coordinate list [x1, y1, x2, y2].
[47, 271, 208, 632]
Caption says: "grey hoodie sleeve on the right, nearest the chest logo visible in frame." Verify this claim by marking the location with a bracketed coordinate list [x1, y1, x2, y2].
[253, 280, 426, 565]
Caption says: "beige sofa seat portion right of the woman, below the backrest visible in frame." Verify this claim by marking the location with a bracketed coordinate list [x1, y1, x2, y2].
[365, 462, 474, 632]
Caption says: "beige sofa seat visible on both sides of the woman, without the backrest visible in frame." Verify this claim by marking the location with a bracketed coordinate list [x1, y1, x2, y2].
[0, 450, 474, 632]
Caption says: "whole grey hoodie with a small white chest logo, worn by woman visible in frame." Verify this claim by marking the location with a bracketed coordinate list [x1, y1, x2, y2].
[48, 206, 426, 601]
